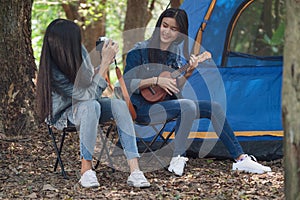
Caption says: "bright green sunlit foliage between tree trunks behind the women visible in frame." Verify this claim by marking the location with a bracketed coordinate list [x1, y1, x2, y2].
[32, 0, 168, 79]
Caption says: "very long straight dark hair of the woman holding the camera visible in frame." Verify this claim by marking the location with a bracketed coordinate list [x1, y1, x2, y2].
[36, 19, 82, 121]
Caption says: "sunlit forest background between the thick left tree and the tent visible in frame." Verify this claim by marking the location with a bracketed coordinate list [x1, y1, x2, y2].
[32, 0, 171, 83]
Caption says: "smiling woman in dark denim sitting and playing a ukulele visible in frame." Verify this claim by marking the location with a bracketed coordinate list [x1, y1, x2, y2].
[124, 8, 271, 176]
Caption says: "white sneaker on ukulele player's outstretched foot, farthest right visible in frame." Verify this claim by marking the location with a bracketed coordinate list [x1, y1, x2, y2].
[232, 155, 272, 174]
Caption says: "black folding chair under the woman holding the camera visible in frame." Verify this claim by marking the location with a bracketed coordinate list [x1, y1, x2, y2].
[47, 121, 115, 179]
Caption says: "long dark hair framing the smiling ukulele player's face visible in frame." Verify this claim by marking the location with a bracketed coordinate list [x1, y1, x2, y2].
[149, 8, 189, 63]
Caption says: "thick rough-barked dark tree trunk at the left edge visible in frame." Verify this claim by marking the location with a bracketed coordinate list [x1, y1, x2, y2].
[0, 0, 36, 135]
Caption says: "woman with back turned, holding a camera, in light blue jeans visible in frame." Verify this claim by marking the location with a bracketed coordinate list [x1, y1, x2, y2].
[36, 19, 150, 187]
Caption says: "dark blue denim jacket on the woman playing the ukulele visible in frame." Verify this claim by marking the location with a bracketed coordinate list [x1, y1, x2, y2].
[124, 40, 185, 108]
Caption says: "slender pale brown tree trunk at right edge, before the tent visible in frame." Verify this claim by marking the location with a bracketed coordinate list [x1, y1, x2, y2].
[282, 0, 300, 200]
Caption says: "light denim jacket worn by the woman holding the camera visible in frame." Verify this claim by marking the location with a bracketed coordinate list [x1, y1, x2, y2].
[50, 46, 107, 129]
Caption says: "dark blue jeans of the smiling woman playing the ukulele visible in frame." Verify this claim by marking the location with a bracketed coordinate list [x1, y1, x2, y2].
[136, 99, 244, 159]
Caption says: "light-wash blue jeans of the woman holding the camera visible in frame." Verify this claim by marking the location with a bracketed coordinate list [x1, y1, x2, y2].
[68, 98, 139, 160]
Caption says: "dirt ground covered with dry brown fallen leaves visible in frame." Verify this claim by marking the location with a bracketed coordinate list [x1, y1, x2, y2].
[0, 127, 284, 200]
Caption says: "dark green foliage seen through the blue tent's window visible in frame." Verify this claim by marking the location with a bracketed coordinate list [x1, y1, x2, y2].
[230, 0, 285, 56]
